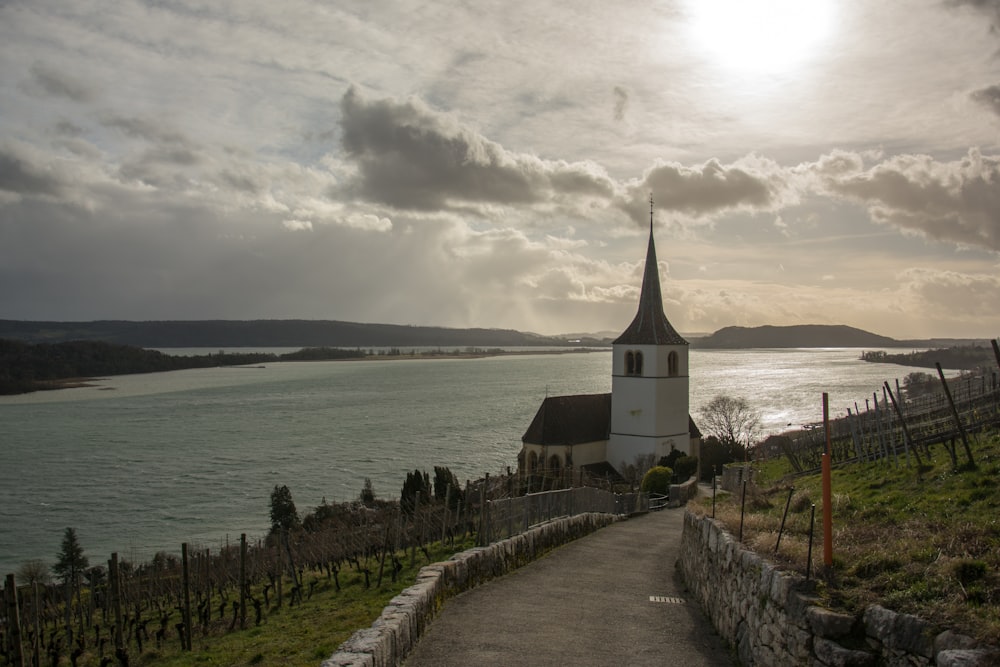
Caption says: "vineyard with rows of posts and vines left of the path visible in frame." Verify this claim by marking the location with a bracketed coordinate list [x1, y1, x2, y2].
[0, 469, 648, 667]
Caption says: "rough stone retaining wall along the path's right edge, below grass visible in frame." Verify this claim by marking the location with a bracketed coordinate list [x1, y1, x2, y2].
[678, 512, 1000, 667]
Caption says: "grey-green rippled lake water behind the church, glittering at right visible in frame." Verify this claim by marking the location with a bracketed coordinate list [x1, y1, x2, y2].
[0, 349, 936, 575]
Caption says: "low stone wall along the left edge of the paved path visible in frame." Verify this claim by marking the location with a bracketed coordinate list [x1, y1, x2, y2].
[321, 513, 619, 667]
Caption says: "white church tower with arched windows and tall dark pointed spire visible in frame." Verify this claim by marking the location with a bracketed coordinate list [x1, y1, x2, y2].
[607, 195, 697, 469]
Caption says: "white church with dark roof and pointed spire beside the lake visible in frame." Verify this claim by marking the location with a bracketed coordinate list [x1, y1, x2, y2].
[518, 197, 701, 486]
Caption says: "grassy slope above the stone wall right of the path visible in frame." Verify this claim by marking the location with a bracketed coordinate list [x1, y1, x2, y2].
[697, 434, 1000, 644]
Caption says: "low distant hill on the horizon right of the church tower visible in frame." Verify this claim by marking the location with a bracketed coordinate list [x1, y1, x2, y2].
[690, 324, 900, 349]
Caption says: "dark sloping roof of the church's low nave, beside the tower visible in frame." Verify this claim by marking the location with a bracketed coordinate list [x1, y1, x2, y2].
[521, 394, 611, 445]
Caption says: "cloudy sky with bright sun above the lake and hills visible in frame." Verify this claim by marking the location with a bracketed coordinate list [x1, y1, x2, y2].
[0, 0, 1000, 338]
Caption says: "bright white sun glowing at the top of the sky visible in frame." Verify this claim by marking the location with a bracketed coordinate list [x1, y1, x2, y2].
[687, 0, 835, 75]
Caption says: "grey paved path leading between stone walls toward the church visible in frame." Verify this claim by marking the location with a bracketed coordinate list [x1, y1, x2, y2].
[404, 509, 736, 667]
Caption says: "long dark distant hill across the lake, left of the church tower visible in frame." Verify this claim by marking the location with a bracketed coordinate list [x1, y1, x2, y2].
[0, 320, 585, 348]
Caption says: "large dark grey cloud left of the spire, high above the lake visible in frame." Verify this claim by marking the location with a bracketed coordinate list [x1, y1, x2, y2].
[341, 88, 613, 210]
